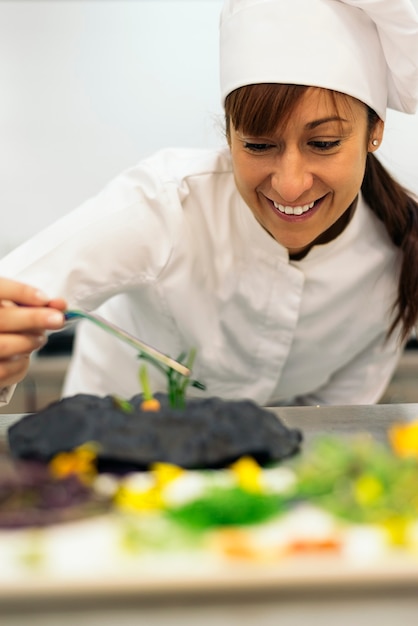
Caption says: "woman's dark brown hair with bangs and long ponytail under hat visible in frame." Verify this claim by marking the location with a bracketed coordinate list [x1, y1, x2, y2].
[225, 84, 418, 340]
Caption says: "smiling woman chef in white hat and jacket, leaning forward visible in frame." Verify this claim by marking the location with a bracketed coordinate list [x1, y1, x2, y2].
[0, 0, 418, 405]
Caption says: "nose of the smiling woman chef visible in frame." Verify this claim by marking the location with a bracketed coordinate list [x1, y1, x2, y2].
[271, 150, 314, 203]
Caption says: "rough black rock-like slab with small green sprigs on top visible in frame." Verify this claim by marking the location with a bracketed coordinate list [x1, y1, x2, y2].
[9, 394, 302, 469]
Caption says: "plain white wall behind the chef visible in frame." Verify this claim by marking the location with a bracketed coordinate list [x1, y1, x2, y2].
[0, 0, 418, 256]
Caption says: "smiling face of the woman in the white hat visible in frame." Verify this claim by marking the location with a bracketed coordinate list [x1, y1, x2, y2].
[228, 88, 383, 255]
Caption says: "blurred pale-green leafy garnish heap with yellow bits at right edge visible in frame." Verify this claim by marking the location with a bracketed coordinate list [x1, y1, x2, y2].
[293, 437, 418, 524]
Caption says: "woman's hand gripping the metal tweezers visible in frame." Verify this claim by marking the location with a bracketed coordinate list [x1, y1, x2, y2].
[0, 278, 66, 387]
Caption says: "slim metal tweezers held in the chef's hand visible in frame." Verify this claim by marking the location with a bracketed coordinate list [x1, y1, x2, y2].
[64, 309, 191, 378]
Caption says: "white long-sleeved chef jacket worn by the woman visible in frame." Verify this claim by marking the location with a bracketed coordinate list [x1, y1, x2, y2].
[0, 149, 402, 405]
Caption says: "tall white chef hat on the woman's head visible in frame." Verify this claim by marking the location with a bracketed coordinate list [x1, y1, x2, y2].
[220, 0, 418, 119]
